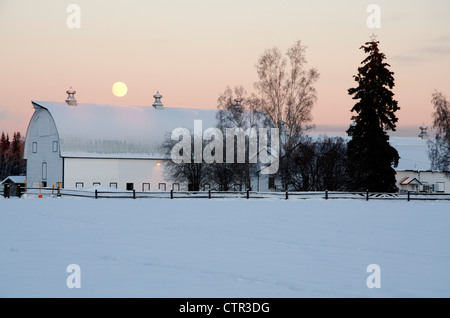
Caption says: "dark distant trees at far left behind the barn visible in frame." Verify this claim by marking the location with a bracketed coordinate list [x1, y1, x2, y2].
[0, 132, 27, 181]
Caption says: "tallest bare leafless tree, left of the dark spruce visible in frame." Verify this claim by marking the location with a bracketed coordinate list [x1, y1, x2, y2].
[255, 41, 319, 189]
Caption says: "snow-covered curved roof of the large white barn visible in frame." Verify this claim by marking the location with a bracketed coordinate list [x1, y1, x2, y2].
[32, 101, 221, 159]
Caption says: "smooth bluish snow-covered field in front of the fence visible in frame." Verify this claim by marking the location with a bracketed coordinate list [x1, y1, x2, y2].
[0, 198, 450, 298]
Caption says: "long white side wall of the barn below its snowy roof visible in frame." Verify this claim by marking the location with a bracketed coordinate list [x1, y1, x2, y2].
[64, 158, 182, 191]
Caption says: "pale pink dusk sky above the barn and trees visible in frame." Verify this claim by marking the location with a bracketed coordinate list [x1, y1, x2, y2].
[0, 0, 450, 134]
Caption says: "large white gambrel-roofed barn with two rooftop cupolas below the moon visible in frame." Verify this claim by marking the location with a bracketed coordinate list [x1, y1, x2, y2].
[24, 90, 267, 191]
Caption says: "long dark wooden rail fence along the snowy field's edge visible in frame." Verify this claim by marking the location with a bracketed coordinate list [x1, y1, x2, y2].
[16, 188, 450, 201]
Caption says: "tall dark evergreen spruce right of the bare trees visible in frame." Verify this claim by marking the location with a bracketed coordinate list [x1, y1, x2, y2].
[347, 39, 400, 192]
